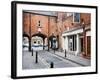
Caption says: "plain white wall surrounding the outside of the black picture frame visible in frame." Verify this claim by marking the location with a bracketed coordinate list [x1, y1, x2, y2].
[0, 0, 100, 80]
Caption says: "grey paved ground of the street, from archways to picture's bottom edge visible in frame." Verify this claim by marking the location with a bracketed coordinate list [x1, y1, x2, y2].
[22, 50, 90, 69]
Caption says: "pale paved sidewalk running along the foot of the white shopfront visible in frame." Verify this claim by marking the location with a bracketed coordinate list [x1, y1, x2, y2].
[50, 50, 91, 66]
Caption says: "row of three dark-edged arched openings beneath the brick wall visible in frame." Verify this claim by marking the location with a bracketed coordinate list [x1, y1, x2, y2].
[23, 33, 59, 50]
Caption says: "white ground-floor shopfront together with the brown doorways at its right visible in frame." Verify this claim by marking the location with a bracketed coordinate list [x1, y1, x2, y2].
[62, 28, 91, 57]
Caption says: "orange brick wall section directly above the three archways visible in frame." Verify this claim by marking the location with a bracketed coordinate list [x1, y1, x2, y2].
[23, 13, 58, 36]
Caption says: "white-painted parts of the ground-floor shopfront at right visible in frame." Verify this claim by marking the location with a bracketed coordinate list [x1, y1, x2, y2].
[62, 26, 91, 55]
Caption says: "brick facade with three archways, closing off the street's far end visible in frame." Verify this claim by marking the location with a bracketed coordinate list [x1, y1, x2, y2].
[23, 11, 59, 49]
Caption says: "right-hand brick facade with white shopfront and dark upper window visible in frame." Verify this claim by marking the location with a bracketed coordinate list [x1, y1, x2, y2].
[62, 13, 91, 58]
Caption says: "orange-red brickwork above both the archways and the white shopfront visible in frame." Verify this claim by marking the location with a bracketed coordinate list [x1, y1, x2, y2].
[23, 12, 91, 48]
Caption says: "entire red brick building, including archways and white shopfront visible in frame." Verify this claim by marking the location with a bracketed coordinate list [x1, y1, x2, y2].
[23, 11, 91, 56]
